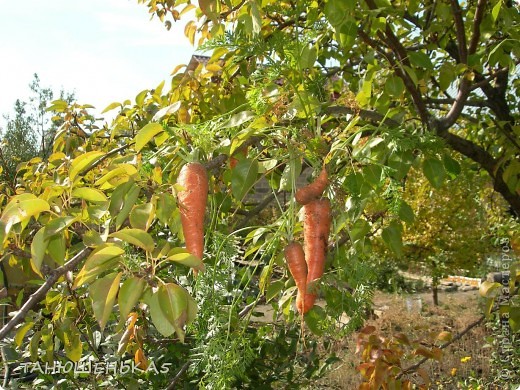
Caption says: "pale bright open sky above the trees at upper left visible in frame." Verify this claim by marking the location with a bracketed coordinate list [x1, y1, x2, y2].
[0, 0, 194, 127]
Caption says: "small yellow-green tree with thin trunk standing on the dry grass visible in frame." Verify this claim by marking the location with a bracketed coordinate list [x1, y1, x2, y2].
[403, 163, 507, 305]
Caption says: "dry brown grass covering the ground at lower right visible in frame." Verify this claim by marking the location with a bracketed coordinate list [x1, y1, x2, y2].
[319, 291, 491, 390]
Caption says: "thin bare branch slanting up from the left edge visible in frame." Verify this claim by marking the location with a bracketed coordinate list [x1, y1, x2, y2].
[0, 248, 92, 340]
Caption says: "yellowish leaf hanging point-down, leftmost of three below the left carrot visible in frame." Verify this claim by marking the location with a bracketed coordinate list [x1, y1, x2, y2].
[89, 272, 122, 331]
